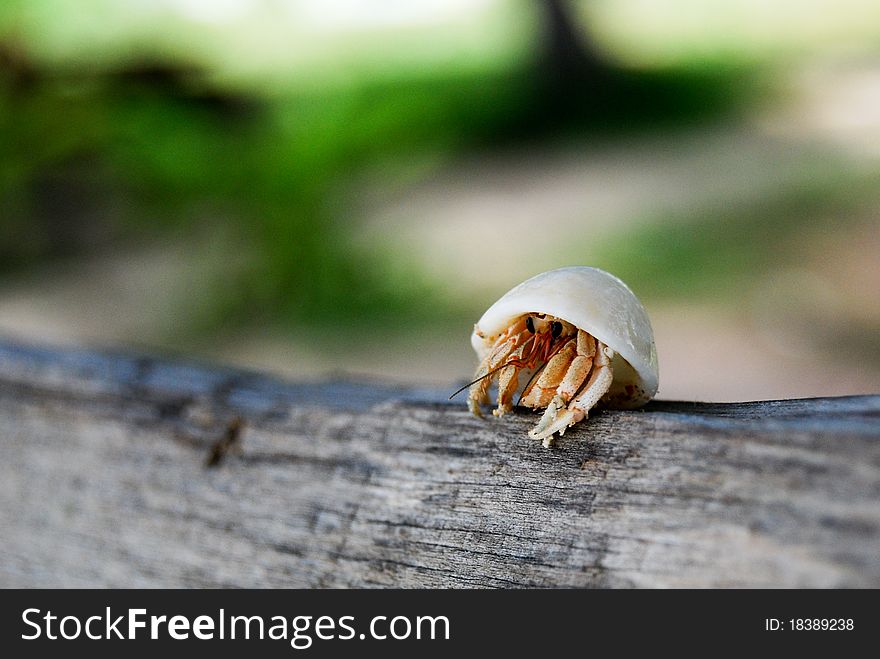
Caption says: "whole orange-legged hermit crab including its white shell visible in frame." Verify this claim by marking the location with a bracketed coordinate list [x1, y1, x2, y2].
[453, 266, 658, 446]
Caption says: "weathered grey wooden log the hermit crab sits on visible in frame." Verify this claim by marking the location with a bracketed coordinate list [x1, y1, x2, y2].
[0, 342, 880, 587]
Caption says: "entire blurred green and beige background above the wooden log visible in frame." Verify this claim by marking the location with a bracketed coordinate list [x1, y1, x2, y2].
[0, 0, 880, 401]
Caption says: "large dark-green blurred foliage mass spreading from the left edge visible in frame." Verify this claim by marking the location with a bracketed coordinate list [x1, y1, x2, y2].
[0, 18, 750, 336]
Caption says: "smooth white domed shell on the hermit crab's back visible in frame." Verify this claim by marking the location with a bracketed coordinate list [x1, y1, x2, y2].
[471, 266, 659, 407]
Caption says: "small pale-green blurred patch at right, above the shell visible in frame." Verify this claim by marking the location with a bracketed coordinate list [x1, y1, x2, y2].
[581, 171, 880, 301]
